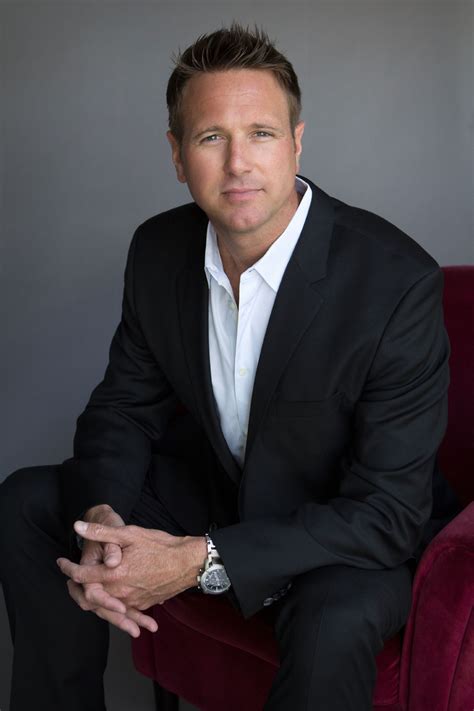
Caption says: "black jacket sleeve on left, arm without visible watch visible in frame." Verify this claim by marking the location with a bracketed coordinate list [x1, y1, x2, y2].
[62, 228, 177, 526]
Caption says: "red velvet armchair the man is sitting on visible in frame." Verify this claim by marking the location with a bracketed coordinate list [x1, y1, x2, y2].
[132, 266, 474, 711]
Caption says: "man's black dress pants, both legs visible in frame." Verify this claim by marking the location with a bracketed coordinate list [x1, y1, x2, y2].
[0, 466, 412, 711]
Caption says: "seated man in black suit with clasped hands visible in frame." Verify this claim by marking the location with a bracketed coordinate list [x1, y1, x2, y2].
[0, 24, 460, 711]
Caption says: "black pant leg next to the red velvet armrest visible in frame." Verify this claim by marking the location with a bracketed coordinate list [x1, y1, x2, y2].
[265, 565, 412, 711]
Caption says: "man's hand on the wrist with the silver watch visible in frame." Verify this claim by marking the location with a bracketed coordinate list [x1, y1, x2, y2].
[57, 521, 207, 636]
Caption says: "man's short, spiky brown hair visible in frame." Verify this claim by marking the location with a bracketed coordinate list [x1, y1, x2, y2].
[166, 22, 301, 143]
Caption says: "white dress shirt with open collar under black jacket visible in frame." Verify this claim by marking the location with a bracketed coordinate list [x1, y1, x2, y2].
[204, 178, 312, 467]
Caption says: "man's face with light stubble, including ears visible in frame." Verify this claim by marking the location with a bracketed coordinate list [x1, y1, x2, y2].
[168, 69, 304, 245]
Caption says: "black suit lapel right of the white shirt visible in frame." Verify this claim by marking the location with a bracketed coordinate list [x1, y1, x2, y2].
[245, 178, 334, 465]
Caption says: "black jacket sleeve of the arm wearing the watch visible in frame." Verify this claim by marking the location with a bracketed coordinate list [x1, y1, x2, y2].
[212, 269, 449, 617]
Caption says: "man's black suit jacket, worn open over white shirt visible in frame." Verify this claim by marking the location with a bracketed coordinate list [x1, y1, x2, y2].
[60, 179, 449, 617]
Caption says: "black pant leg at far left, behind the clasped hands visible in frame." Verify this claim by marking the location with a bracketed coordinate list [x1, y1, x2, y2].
[0, 465, 193, 711]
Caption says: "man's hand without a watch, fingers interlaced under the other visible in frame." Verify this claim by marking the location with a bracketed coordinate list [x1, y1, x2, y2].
[67, 504, 158, 637]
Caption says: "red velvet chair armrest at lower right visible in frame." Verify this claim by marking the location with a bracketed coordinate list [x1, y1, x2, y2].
[400, 502, 474, 711]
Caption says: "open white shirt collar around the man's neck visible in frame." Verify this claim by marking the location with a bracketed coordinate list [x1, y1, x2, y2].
[204, 176, 312, 292]
